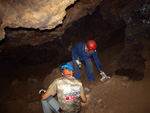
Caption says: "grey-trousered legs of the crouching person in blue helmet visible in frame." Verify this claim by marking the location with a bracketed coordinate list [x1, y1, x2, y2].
[41, 96, 60, 113]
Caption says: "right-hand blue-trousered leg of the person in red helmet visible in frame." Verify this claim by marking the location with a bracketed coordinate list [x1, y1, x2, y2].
[84, 58, 95, 81]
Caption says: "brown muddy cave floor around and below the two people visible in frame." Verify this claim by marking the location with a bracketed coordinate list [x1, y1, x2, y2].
[0, 43, 150, 113]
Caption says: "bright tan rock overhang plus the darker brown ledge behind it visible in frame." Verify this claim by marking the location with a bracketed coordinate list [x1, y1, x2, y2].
[0, 0, 100, 40]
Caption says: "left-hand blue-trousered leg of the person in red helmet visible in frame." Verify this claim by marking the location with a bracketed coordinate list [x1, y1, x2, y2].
[72, 57, 80, 80]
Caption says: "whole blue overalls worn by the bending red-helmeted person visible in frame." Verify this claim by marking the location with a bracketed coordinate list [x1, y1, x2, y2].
[72, 42, 102, 81]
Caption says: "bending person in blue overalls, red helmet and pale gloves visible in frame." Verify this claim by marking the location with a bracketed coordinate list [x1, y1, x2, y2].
[72, 40, 110, 82]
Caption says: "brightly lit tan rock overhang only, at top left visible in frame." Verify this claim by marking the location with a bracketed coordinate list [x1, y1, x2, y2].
[0, 0, 75, 39]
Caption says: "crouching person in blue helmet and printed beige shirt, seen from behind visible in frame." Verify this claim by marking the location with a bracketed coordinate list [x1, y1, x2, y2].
[39, 62, 87, 113]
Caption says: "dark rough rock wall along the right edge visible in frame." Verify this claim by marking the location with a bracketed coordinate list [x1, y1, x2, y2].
[102, 0, 150, 79]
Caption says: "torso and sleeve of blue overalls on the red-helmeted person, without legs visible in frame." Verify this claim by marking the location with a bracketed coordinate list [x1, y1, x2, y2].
[72, 42, 103, 71]
